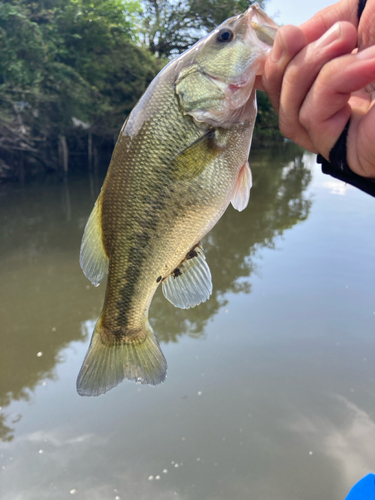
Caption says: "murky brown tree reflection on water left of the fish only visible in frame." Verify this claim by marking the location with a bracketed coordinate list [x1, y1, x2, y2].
[0, 178, 97, 439]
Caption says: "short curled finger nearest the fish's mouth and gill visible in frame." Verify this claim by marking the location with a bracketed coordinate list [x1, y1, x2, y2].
[262, 25, 307, 112]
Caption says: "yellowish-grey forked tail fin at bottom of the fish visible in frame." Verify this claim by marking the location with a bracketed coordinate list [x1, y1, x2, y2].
[77, 319, 167, 396]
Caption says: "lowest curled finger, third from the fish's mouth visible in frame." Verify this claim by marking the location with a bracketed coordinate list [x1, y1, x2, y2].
[299, 46, 375, 165]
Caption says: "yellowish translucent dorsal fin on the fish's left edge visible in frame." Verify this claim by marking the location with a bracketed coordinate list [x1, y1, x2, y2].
[79, 195, 108, 286]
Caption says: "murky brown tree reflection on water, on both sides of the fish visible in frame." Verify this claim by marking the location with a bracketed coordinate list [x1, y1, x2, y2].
[0, 145, 311, 441]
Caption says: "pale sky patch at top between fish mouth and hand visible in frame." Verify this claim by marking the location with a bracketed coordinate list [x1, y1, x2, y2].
[266, 0, 335, 25]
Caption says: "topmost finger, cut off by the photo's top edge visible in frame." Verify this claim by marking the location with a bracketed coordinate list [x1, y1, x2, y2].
[299, 0, 358, 43]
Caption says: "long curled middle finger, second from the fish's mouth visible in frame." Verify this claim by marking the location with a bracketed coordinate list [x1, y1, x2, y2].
[279, 22, 357, 152]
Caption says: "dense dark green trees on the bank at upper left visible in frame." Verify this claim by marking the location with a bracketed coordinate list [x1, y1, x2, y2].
[0, 0, 160, 179]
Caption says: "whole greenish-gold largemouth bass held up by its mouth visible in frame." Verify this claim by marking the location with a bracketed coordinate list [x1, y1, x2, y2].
[77, 4, 277, 396]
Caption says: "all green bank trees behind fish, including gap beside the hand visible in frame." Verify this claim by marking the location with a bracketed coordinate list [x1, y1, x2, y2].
[0, 0, 277, 179]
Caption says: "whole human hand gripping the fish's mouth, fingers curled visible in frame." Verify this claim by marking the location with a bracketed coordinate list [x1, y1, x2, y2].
[262, 0, 375, 177]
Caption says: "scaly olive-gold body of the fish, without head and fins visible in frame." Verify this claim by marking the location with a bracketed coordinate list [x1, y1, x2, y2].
[102, 91, 234, 328]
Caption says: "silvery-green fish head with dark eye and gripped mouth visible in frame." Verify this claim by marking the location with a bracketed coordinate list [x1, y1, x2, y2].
[175, 4, 278, 127]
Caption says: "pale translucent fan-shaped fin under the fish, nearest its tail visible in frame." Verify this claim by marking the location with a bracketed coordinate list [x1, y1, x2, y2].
[162, 245, 212, 309]
